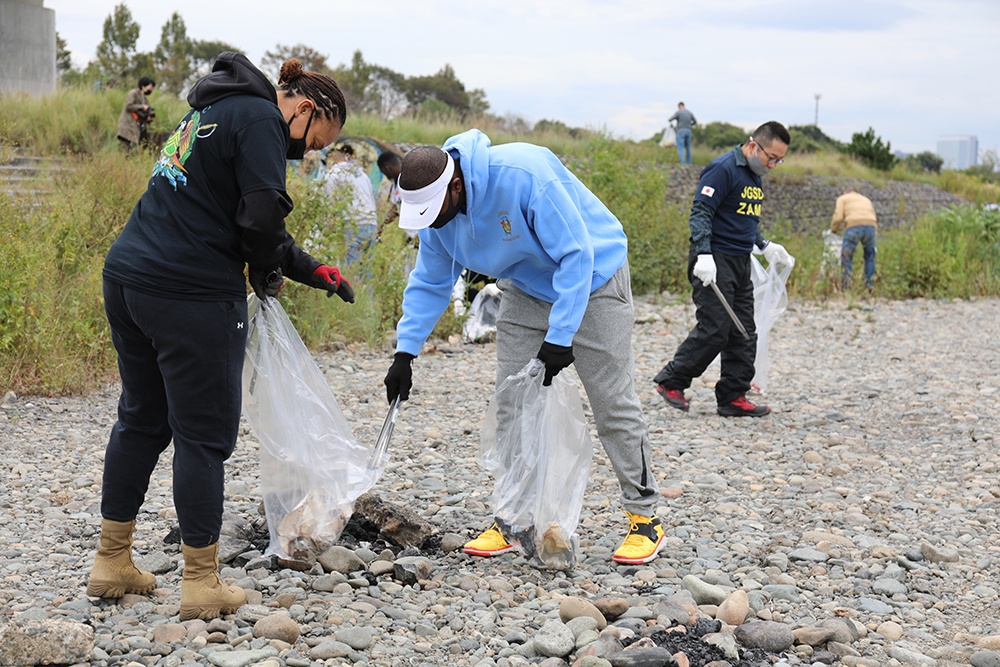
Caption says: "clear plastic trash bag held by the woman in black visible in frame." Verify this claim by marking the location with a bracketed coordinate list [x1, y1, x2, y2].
[243, 294, 386, 563]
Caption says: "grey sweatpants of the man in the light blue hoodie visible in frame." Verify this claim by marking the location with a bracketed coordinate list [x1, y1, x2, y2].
[497, 262, 659, 516]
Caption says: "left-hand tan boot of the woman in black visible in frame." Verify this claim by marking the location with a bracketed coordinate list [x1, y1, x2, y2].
[87, 519, 156, 598]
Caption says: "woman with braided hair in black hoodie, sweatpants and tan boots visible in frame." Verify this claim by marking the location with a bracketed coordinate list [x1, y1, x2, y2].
[87, 52, 354, 619]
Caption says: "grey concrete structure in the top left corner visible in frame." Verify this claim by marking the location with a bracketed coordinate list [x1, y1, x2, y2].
[0, 0, 56, 95]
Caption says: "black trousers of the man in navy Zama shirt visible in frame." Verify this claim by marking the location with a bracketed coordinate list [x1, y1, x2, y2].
[653, 252, 757, 405]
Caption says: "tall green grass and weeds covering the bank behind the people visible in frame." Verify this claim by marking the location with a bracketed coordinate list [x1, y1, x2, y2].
[0, 89, 1000, 394]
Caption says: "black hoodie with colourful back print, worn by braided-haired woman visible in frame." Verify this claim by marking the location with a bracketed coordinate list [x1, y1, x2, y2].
[104, 51, 319, 301]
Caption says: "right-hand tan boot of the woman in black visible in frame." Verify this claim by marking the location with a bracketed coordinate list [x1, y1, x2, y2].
[181, 542, 247, 621]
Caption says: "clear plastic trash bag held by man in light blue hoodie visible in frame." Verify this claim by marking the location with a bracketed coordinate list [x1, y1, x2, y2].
[479, 359, 593, 570]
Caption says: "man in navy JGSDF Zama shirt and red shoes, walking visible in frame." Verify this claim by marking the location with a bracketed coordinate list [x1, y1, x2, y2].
[653, 121, 795, 417]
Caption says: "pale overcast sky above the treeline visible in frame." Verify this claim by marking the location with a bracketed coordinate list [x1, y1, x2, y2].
[44, 0, 1000, 157]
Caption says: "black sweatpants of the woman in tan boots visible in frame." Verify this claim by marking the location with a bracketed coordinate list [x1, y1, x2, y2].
[101, 280, 247, 547]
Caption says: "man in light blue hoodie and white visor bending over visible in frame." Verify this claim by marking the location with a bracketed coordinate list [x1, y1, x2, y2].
[385, 130, 664, 564]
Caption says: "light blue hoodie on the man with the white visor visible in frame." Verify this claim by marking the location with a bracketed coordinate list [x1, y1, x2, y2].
[396, 130, 628, 355]
